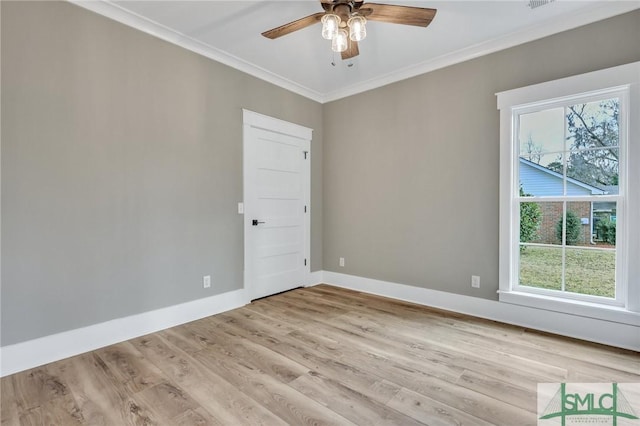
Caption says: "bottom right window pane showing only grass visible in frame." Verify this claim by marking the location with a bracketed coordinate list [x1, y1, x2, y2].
[565, 248, 616, 298]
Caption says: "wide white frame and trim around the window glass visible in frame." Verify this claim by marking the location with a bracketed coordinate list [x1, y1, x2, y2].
[497, 62, 640, 325]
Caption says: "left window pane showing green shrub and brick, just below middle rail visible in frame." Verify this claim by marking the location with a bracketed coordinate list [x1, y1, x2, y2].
[520, 202, 562, 244]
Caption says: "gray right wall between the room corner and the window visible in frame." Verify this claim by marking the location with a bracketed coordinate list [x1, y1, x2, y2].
[323, 11, 640, 299]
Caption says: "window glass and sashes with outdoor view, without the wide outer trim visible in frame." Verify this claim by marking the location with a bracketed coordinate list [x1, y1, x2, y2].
[512, 93, 628, 305]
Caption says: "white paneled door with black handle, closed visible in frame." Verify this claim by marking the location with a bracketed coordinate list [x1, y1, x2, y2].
[243, 110, 311, 300]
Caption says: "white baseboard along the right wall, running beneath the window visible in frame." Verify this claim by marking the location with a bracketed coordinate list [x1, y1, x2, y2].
[322, 271, 640, 351]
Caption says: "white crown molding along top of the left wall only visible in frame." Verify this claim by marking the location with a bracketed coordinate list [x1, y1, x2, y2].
[67, 0, 323, 102]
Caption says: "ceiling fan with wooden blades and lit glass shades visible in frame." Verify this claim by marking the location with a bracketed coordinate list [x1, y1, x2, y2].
[262, 0, 436, 59]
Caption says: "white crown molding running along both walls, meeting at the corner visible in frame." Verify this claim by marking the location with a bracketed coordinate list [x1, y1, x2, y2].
[67, 0, 640, 103]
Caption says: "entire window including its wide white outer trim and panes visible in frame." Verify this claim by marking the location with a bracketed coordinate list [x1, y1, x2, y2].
[498, 63, 640, 321]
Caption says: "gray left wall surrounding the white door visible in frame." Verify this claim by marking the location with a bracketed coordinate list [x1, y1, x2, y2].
[1, 1, 322, 346]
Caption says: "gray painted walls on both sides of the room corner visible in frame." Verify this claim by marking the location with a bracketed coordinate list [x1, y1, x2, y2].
[0, 1, 640, 346]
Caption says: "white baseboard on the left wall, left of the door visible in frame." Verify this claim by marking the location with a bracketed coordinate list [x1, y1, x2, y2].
[0, 289, 247, 377]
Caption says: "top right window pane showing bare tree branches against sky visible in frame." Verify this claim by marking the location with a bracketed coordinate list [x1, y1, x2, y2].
[567, 98, 620, 149]
